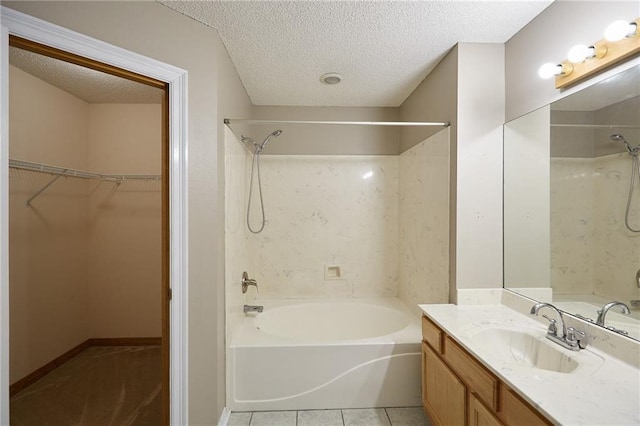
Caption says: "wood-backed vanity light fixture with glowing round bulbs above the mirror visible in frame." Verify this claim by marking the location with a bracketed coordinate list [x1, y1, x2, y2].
[538, 18, 640, 89]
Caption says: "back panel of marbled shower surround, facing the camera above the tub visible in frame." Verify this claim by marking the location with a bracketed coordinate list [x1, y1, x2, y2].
[251, 155, 398, 298]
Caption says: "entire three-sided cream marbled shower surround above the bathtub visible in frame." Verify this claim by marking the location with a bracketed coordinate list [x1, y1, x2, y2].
[225, 129, 449, 341]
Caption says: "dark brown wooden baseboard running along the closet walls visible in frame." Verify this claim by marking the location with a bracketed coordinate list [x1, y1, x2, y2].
[9, 337, 162, 397]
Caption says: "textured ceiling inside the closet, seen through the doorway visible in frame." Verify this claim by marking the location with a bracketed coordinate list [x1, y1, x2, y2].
[9, 47, 164, 104]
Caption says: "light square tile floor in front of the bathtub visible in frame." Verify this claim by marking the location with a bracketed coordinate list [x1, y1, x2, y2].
[227, 407, 431, 426]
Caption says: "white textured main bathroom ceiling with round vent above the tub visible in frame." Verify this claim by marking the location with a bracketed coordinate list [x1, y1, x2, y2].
[160, 0, 551, 107]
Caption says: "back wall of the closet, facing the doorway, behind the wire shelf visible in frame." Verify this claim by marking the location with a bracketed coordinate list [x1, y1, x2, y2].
[86, 104, 162, 337]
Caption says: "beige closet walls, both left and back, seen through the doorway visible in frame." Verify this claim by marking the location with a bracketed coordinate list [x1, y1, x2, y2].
[9, 67, 161, 383]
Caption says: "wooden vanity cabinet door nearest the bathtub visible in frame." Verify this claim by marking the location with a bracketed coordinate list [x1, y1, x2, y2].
[422, 343, 466, 426]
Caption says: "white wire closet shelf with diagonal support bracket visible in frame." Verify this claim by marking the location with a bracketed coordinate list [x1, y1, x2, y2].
[9, 159, 162, 206]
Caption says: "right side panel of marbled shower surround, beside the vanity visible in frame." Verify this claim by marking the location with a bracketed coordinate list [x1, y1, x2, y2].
[398, 128, 450, 315]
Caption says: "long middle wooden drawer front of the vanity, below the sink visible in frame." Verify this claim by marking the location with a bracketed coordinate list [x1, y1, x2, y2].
[444, 336, 498, 411]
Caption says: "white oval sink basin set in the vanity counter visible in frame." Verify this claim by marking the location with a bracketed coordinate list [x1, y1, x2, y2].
[472, 328, 580, 373]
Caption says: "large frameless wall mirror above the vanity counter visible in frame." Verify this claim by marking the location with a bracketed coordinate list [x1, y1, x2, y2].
[504, 66, 640, 340]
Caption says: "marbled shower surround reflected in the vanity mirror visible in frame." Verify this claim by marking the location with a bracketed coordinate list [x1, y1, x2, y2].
[551, 153, 640, 301]
